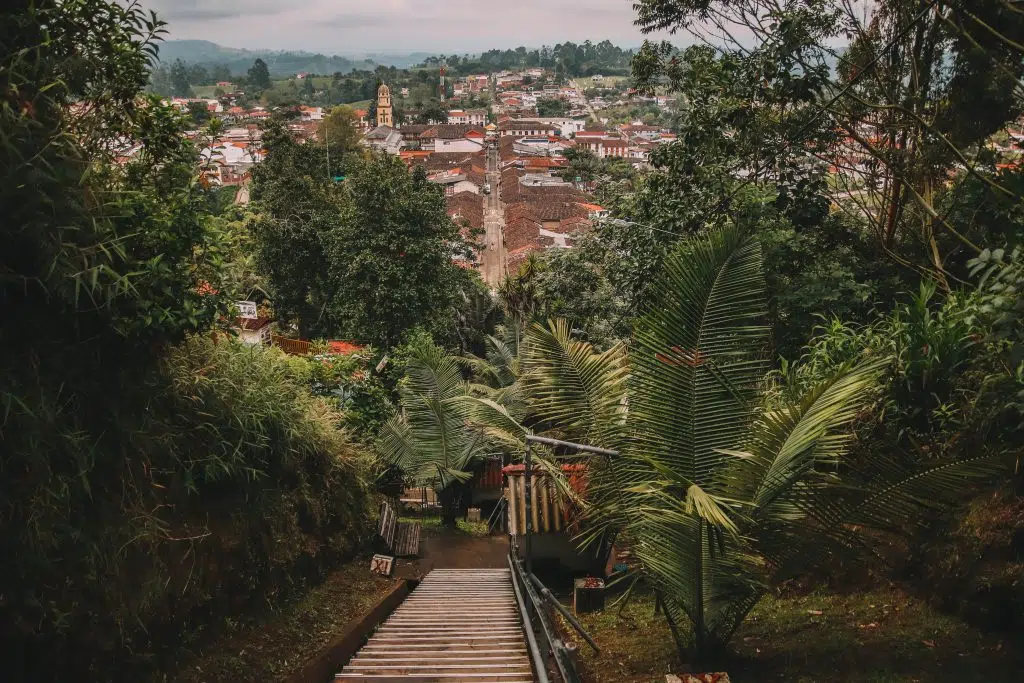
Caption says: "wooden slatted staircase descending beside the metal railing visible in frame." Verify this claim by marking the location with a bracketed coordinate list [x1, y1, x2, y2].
[335, 569, 536, 683]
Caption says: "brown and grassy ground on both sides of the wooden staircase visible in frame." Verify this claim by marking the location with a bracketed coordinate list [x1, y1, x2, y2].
[164, 517, 1024, 683]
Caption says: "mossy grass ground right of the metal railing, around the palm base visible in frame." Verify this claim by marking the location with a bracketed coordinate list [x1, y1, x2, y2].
[581, 587, 1024, 683]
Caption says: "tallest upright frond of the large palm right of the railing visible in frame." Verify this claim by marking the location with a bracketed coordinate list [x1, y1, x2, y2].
[630, 228, 769, 487]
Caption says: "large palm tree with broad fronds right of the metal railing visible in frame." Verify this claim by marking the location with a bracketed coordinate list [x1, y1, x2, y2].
[523, 228, 995, 658]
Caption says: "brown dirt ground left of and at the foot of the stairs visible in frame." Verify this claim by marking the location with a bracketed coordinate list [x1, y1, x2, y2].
[158, 517, 508, 683]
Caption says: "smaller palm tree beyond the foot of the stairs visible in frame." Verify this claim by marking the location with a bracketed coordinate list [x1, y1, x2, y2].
[378, 344, 525, 525]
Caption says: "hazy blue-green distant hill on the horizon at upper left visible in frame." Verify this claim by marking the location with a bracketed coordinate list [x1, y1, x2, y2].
[152, 40, 430, 77]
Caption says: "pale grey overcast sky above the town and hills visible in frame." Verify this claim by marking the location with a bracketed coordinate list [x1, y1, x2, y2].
[136, 0, 688, 54]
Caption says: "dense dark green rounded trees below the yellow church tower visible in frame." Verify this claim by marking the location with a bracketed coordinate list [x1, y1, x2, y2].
[252, 124, 473, 348]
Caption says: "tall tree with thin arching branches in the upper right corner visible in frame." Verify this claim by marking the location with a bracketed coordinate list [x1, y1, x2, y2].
[634, 0, 1024, 291]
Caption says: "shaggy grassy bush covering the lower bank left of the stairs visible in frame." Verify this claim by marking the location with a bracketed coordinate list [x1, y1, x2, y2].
[0, 337, 370, 680]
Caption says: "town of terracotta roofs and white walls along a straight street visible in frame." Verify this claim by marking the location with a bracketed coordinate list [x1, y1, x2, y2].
[159, 58, 676, 288]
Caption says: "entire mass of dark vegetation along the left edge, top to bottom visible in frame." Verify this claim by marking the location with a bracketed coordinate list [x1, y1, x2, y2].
[0, 1, 372, 681]
